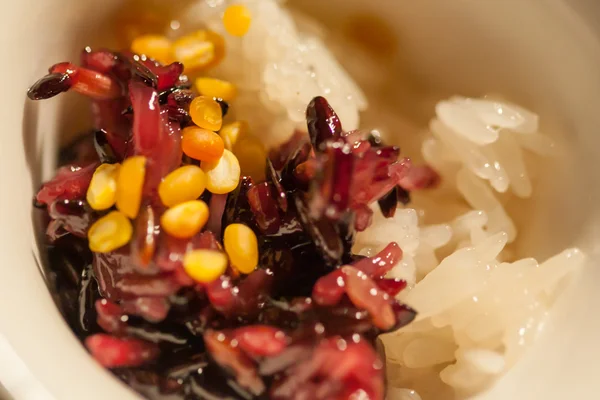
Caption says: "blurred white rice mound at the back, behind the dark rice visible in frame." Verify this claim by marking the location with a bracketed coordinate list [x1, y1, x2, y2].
[176, 0, 367, 146]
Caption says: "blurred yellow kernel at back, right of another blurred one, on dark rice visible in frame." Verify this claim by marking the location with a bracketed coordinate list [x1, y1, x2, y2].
[173, 30, 225, 73]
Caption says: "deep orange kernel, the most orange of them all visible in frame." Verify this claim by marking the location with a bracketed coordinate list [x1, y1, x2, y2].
[181, 126, 225, 162]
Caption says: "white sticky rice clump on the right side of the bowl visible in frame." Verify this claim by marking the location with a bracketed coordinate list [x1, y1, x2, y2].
[356, 97, 584, 400]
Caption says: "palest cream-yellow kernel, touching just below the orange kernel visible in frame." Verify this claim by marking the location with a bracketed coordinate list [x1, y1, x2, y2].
[200, 150, 240, 194]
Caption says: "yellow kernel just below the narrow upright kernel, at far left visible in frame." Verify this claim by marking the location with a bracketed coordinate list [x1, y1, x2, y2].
[88, 211, 133, 253]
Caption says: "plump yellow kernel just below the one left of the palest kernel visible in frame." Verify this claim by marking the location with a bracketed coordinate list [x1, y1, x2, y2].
[160, 200, 208, 239]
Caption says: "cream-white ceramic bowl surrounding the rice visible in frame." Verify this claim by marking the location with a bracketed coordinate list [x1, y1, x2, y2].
[0, 0, 600, 400]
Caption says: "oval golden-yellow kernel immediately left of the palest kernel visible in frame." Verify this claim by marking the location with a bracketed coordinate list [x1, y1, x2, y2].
[158, 165, 206, 207]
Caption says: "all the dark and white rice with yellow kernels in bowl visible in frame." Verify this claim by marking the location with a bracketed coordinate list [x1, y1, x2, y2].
[29, 1, 583, 399]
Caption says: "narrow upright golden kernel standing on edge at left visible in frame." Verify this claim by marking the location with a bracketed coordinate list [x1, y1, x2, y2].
[116, 156, 146, 219]
